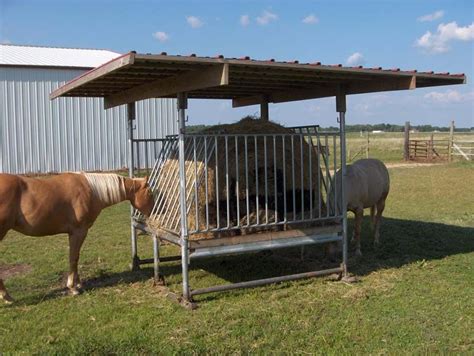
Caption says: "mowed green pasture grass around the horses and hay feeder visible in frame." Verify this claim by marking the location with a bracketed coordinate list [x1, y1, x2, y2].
[0, 163, 474, 354]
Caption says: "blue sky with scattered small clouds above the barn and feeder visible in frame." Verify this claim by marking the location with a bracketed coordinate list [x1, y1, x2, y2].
[0, 0, 474, 127]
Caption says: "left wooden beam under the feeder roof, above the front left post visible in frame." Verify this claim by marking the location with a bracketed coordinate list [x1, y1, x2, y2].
[104, 63, 229, 109]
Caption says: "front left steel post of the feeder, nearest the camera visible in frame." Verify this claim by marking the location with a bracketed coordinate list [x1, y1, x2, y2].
[178, 93, 191, 301]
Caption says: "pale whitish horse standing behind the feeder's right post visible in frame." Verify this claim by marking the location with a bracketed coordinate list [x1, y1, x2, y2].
[329, 159, 390, 256]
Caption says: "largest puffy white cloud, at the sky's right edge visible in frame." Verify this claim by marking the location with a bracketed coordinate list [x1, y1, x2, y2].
[415, 22, 474, 53]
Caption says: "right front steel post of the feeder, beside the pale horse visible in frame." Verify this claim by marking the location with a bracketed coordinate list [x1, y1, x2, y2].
[336, 87, 348, 277]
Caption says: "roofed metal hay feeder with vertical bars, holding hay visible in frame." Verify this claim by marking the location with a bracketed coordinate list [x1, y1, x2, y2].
[50, 52, 466, 305]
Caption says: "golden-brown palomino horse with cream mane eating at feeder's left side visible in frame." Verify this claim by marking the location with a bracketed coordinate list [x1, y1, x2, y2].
[0, 173, 153, 302]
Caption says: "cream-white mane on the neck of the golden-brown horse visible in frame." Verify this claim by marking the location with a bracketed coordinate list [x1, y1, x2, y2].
[82, 173, 126, 206]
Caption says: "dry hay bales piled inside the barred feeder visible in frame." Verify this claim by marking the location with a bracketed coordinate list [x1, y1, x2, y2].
[149, 118, 325, 238]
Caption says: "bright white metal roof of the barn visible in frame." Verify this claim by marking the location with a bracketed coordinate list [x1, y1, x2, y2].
[0, 44, 120, 68]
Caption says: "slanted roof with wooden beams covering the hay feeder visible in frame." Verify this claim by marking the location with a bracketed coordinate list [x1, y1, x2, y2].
[50, 52, 466, 108]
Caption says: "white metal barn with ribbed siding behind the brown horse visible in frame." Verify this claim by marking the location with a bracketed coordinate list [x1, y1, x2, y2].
[0, 44, 177, 174]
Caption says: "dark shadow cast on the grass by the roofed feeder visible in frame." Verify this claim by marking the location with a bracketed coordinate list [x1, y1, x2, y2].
[12, 218, 474, 304]
